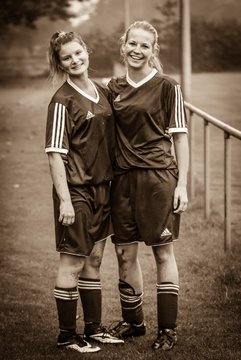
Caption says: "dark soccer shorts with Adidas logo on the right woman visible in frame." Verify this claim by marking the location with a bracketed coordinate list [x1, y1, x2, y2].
[111, 169, 180, 246]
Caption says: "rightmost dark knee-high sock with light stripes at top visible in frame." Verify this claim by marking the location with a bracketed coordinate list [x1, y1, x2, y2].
[156, 282, 179, 330]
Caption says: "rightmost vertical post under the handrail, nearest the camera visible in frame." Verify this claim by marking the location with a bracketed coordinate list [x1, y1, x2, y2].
[224, 132, 231, 251]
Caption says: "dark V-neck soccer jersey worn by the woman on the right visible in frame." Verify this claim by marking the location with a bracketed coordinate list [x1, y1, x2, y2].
[108, 70, 187, 172]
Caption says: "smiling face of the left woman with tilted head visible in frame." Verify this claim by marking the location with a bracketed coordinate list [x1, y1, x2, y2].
[59, 40, 89, 76]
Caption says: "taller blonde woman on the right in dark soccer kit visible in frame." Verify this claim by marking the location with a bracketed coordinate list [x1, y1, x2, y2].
[108, 21, 189, 350]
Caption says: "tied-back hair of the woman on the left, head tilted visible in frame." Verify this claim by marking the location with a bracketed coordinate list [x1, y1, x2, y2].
[48, 31, 87, 84]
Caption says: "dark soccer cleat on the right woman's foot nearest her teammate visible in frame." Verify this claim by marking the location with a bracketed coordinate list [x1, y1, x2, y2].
[110, 321, 146, 338]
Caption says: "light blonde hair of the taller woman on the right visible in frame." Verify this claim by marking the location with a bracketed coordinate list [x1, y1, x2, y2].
[120, 20, 163, 73]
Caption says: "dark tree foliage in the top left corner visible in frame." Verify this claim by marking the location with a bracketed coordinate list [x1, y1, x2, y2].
[0, 0, 83, 29]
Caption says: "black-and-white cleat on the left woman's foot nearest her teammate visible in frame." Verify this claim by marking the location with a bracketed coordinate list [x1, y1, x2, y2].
[84, 325, 124, 344]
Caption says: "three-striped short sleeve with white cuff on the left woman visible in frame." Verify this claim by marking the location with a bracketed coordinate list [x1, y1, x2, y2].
[45, 102, 69, 154]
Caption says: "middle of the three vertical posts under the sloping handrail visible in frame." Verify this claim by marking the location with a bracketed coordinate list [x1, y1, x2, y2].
[204, 119, 210, 219]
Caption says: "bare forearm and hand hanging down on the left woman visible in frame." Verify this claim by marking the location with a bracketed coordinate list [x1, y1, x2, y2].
[48, 152, 75, 226]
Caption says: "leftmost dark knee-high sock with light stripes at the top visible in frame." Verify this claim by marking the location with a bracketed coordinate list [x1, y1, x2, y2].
[54, 287, 79, 333]
